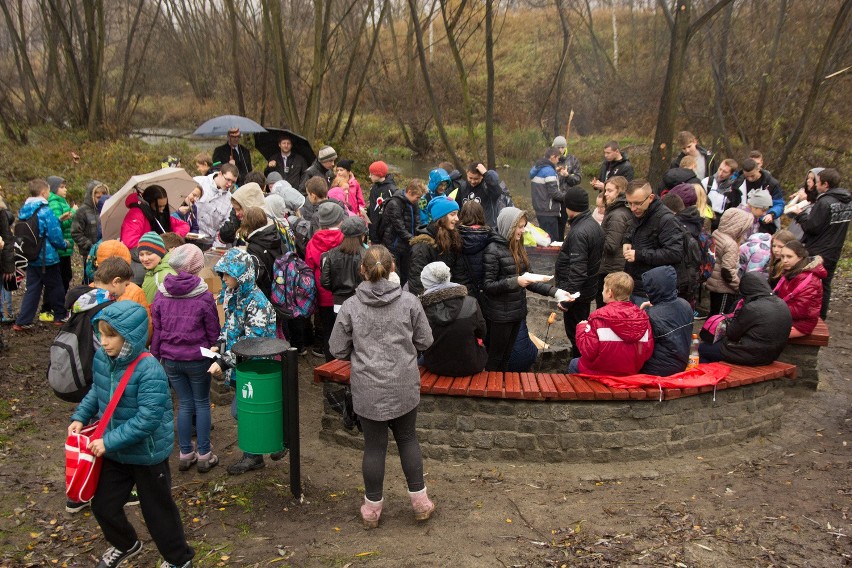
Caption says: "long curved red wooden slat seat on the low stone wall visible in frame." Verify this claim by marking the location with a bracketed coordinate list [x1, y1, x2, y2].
[314, 360, 797, 401]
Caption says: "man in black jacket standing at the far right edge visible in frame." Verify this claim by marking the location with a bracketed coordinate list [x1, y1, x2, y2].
[796, 168, 852, 319]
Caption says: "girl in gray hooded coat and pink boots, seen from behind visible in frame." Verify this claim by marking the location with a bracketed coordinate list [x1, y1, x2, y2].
[329, 245, 435, 529]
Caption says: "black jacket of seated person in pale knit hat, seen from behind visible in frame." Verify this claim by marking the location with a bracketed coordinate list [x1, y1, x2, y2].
[420, 286, 488, 377]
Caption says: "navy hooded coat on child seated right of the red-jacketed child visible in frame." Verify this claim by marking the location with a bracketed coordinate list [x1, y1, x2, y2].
[641, 266, 693, 377]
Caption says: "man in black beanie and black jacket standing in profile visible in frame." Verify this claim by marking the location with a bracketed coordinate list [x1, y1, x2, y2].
[556, 187, 604, 359]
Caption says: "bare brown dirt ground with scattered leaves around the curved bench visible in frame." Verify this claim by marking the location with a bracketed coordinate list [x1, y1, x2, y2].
[0, 278, 852, 567]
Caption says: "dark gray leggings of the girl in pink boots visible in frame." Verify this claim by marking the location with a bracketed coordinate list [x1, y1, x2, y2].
[359, 407, 426, 501]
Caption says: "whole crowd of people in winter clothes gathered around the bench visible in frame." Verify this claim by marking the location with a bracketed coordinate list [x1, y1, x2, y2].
[0, 126, 852, 566]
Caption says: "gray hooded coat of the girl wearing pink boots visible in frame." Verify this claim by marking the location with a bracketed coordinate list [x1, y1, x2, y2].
[329, 278, 432, 421]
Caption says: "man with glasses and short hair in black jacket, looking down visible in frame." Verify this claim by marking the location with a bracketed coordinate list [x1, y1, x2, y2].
[624, 183, 684, 306]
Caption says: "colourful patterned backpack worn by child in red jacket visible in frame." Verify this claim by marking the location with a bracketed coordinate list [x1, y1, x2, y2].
[270, 251, 317, 318]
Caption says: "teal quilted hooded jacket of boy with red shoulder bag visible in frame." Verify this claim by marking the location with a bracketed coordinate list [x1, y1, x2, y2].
[71, 301, 174, 465]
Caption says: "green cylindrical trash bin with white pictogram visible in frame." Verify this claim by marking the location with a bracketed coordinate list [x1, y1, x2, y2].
[235, 359, 284, 454]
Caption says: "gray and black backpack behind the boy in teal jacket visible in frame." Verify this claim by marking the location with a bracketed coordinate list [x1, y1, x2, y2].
[47, 300, 113, 402]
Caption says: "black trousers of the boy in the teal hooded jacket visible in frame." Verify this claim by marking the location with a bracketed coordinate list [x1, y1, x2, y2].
[92, 458, 195, 566]
